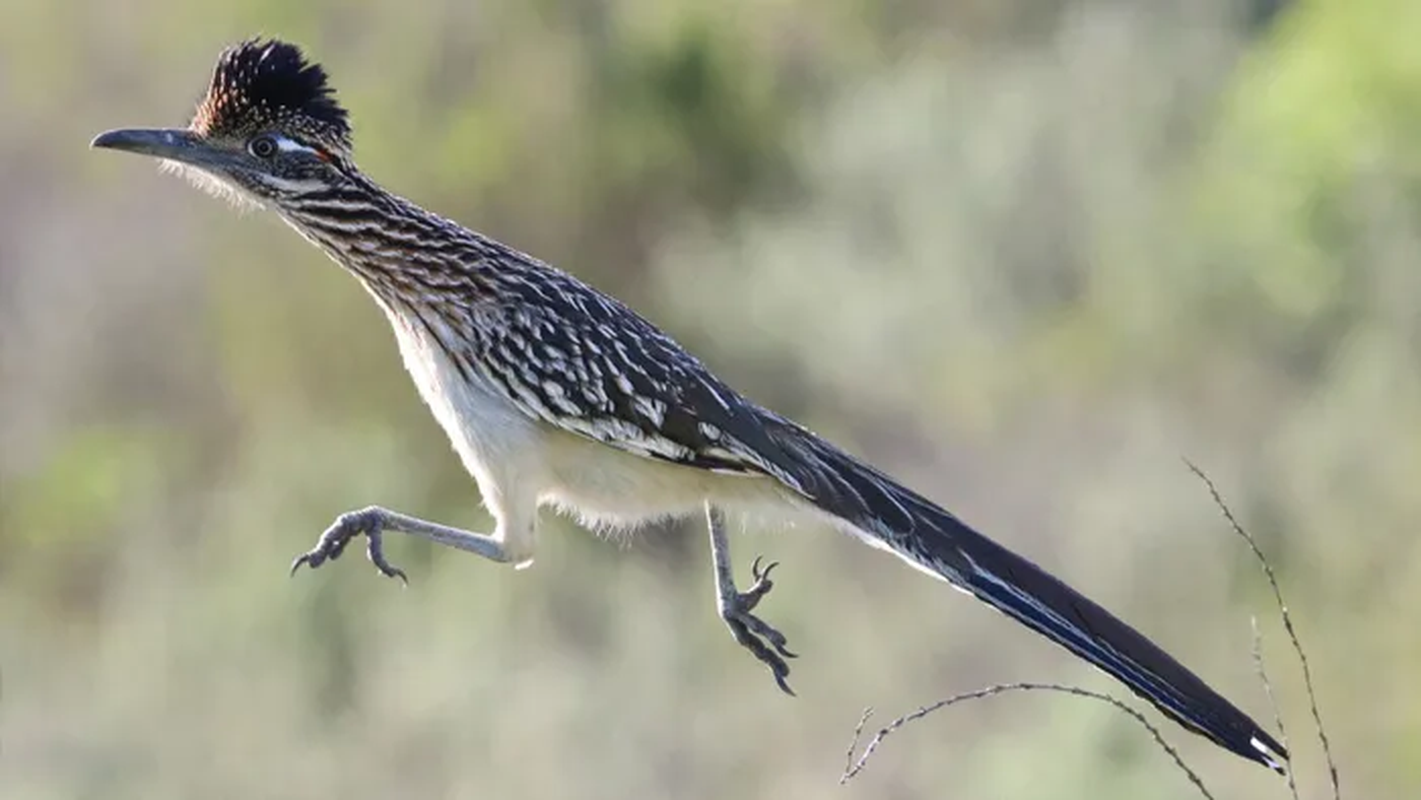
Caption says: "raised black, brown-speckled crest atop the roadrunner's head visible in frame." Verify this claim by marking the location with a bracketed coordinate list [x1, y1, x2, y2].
[192, 38, 351, 149]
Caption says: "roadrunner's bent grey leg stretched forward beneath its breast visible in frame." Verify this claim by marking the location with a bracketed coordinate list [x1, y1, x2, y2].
[291, 506, 527, 583]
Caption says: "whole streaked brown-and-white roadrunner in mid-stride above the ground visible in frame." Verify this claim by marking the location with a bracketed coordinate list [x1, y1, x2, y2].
[92, 40, 1287, 772]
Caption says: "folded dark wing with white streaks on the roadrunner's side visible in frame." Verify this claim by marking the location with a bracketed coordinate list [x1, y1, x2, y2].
[472, 274, 799, 490]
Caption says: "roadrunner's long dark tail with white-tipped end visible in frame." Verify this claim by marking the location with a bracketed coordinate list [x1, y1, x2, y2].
[776, 432, 1287, 773]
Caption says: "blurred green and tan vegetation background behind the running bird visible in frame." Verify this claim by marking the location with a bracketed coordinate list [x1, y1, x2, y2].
[0, 0, 1421, 800]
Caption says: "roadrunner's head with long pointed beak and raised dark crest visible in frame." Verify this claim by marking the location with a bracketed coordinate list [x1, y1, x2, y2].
[91, 38, 351, 205]
